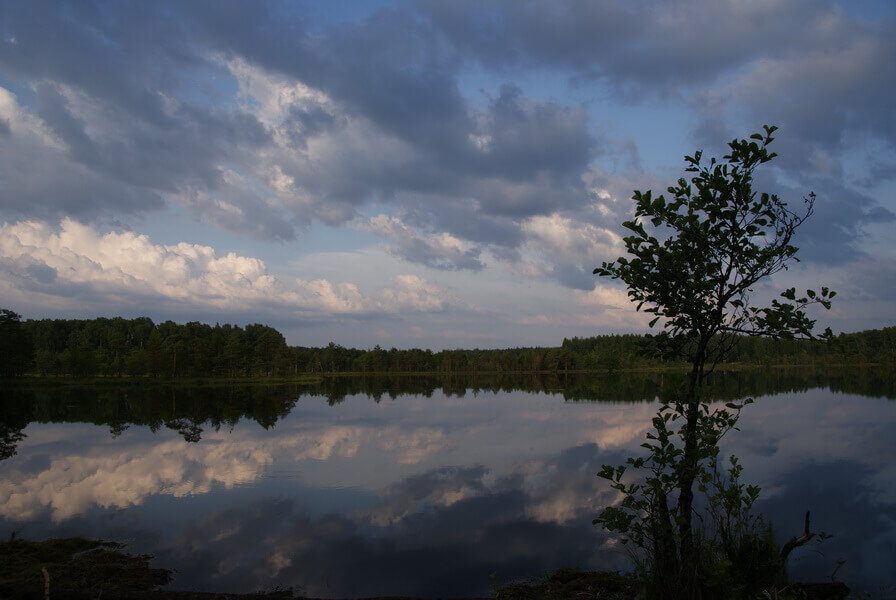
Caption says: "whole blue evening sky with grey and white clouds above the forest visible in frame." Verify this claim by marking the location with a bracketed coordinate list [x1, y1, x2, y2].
[0, 0, 896, 350]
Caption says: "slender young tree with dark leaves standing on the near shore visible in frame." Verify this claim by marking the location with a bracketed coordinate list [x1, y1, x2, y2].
[594, 126, 835, 596]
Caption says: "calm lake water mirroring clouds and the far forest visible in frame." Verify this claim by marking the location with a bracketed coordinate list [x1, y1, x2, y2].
[0, 371, 896, 597]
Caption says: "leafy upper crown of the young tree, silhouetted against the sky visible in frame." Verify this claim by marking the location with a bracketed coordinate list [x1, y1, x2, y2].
[594, 126, 836, 368]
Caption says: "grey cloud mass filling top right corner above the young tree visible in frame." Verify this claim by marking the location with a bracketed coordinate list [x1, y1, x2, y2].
[416, 0, 896, 258]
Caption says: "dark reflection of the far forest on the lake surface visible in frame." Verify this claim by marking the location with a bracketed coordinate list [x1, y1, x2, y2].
[0, 367, 896, 460]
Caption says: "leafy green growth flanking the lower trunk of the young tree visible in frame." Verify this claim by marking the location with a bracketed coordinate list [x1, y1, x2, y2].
[595, 398, 783, 599]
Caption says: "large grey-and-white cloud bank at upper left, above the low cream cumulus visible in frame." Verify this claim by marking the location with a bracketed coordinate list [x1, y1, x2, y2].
[0, 2, 596, 258]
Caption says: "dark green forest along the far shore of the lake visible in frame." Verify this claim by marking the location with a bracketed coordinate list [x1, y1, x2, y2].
[0, 309, 896, 379]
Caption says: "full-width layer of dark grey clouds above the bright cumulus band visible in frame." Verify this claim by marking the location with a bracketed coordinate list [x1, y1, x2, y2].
[0, 0, 896, 288]
